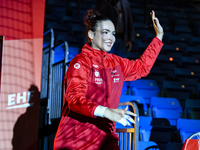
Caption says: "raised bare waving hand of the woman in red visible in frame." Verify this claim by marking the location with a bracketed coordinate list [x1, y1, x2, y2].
[150, 10, 164, 41]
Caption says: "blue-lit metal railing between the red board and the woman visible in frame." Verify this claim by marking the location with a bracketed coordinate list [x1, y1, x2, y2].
[40, 28, 69, 125]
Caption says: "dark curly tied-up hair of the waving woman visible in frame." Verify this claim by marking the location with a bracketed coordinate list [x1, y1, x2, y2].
[84, 9, 110, 42]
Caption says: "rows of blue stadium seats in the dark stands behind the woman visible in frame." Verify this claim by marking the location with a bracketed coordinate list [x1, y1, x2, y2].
[41, 0, 200, 150]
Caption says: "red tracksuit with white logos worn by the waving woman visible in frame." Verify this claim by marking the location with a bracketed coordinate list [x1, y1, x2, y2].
[54, 37, 163, 150]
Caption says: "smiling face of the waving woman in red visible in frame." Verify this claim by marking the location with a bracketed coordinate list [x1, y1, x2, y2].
[88, 20, 115, 52]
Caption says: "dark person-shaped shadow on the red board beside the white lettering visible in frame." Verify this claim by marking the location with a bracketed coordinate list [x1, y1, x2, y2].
[12, 85, 40, 150]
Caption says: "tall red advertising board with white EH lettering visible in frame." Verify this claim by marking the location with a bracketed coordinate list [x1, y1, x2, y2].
[0, 0, 45, 150]
